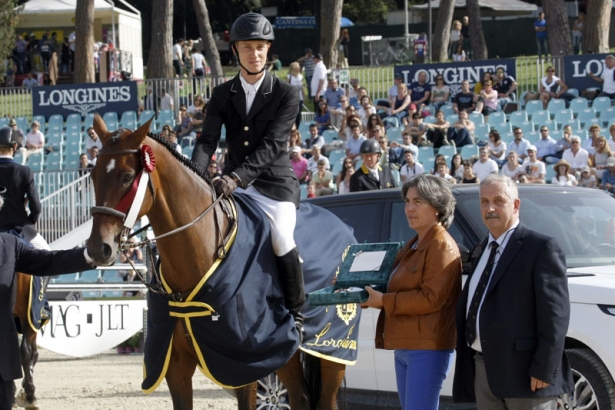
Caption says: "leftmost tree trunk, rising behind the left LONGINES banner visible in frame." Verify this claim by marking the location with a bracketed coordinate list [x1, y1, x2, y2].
[73, 0, 96, 84]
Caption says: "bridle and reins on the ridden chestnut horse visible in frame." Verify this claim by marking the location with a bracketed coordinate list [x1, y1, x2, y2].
[90, 145, 237, 302]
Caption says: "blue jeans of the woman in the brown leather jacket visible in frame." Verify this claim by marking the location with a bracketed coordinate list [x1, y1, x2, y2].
[395, 349, 453, 410]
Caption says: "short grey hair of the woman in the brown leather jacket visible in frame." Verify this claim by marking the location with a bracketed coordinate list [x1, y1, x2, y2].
[401, 175, 456, 229]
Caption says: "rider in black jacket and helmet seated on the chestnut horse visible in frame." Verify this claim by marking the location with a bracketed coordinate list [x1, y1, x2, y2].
[192, 13, 305, 340]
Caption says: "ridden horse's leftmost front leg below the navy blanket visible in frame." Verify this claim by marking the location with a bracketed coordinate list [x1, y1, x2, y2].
[165, 319, 197, 410]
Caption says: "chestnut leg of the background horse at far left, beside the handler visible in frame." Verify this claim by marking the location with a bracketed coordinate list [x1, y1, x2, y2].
[13, 273, 40, 410]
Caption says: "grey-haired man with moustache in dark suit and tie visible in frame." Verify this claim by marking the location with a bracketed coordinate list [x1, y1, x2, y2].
[453, 175, 574, 410]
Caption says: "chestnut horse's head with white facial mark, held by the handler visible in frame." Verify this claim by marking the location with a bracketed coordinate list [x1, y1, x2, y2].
[87, 114, 153, 265]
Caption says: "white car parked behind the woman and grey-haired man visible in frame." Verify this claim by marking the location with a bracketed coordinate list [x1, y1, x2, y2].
[310, 185, 615, 409]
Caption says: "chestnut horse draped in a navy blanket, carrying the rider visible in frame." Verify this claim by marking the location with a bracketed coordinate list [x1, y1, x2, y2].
[87, 115, 345, 410]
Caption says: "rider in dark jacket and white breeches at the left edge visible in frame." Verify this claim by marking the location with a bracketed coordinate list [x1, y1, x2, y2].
[0, 127, 49, 250]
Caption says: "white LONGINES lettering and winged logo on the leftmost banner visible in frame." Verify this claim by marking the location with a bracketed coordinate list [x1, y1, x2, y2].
[38, 86, 130, 116]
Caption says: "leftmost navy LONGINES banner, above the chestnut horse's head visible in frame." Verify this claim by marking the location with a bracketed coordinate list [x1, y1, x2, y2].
[32, 81, 139, 118]
